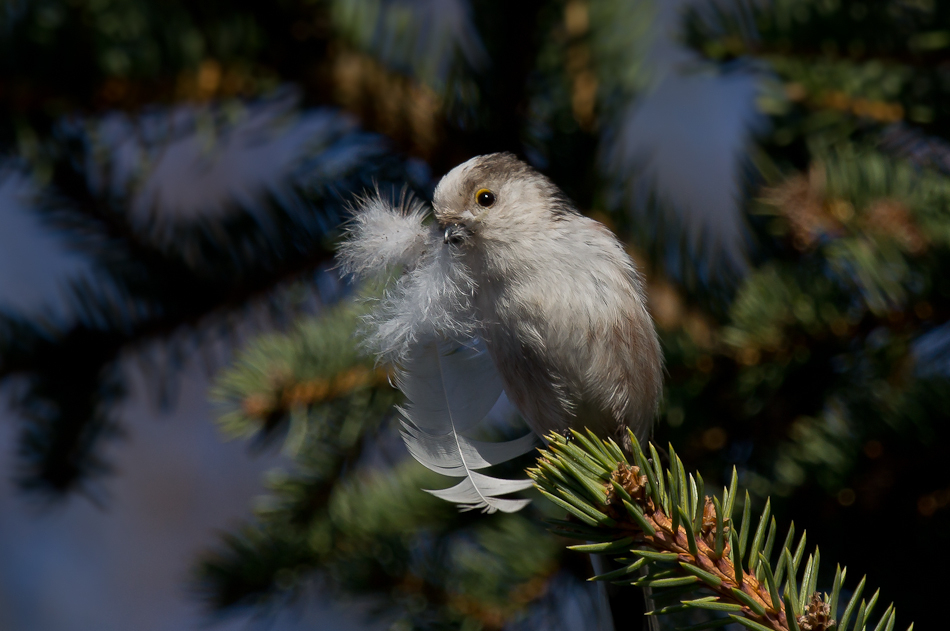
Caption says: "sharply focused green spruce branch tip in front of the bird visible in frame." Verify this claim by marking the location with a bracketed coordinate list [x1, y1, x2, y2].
[528, 430, 913, 631]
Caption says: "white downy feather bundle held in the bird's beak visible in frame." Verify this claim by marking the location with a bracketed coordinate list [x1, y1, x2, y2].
[337, 192, 539, 512]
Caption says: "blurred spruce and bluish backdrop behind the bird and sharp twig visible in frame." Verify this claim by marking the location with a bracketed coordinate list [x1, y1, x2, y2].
[0, 0, 950, 631]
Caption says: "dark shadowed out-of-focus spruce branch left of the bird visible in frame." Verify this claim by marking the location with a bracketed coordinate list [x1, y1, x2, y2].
[0, 119, 420, 495]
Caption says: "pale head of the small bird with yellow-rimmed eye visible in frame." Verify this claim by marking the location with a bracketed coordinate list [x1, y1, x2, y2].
[433, 153, 577, 242]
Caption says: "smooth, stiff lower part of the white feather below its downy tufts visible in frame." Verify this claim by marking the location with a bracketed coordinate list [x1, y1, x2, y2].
[396, 340, 539, 513]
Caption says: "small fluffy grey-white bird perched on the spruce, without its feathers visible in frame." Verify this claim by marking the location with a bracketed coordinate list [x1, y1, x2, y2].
[433, 153, 663, 450]
